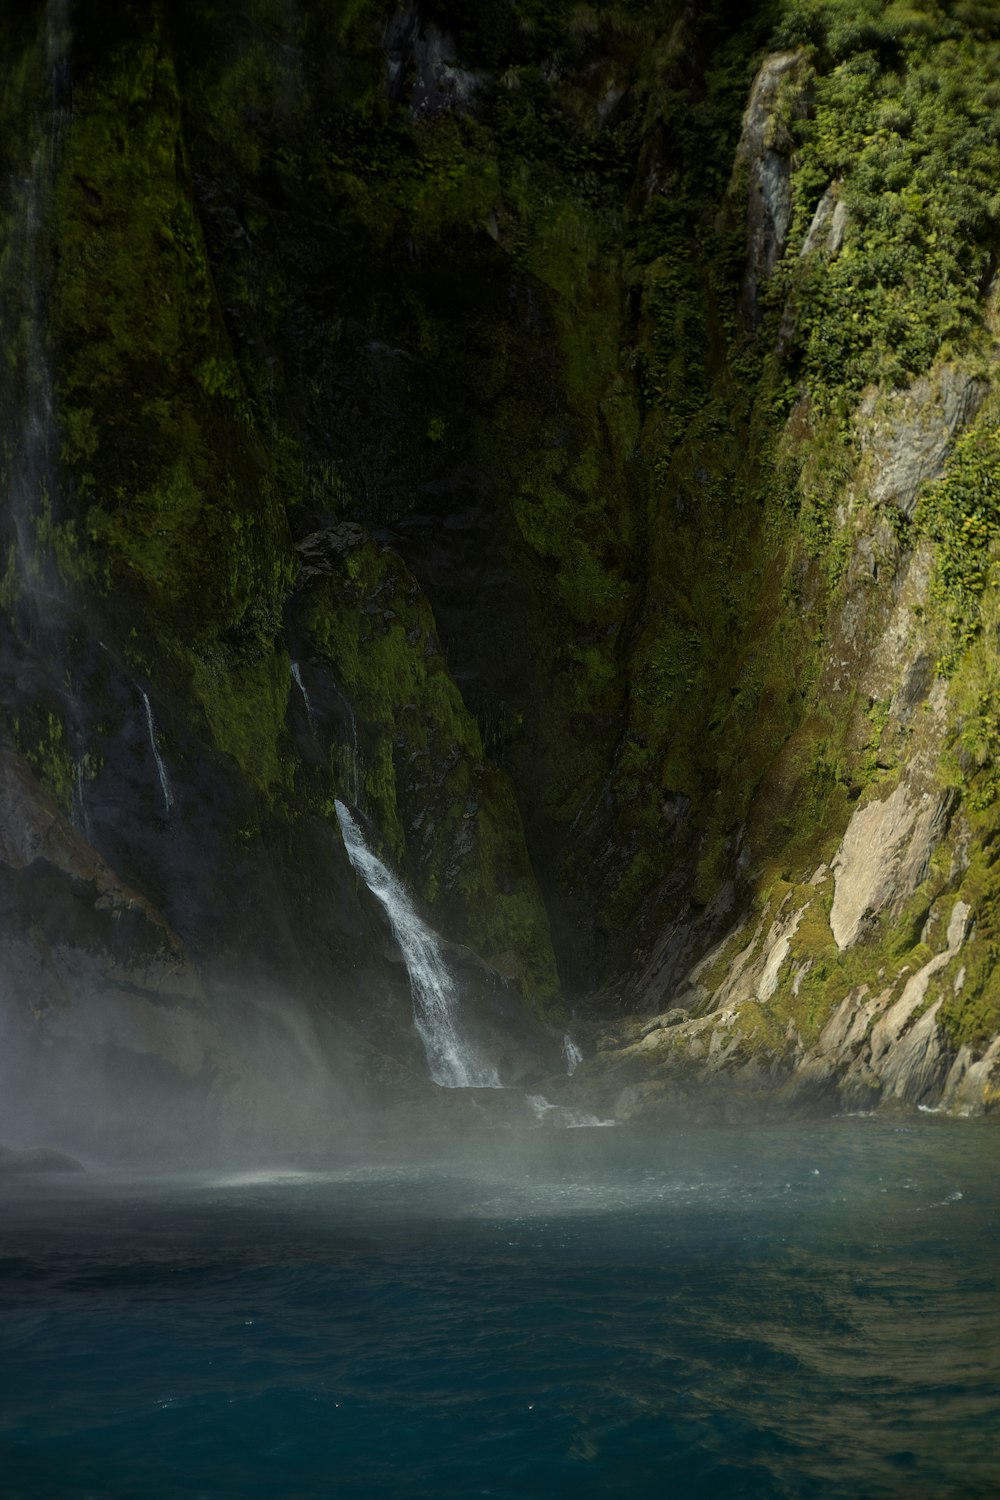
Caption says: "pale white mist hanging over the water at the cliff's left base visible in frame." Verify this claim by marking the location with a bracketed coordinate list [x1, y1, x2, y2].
[0, 990, 370, 1170]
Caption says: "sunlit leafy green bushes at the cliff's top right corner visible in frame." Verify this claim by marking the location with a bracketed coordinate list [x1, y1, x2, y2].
[772, 0, 1000, 396]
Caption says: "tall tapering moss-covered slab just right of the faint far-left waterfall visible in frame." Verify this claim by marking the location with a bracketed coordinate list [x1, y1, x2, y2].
[46, 8, 294, 810]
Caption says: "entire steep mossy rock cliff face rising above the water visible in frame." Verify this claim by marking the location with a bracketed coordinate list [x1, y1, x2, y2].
[0, 0, 1000, 1116]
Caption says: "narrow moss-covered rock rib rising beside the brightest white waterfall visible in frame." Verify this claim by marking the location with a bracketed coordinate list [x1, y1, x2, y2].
[298, 542, 559, 1014]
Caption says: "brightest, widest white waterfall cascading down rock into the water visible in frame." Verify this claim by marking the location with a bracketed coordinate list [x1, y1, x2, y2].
[336, 801, 501, 1089]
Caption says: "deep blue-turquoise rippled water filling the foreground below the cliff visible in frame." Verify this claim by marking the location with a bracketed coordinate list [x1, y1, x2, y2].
[0, 1119, 1000, 1500]
